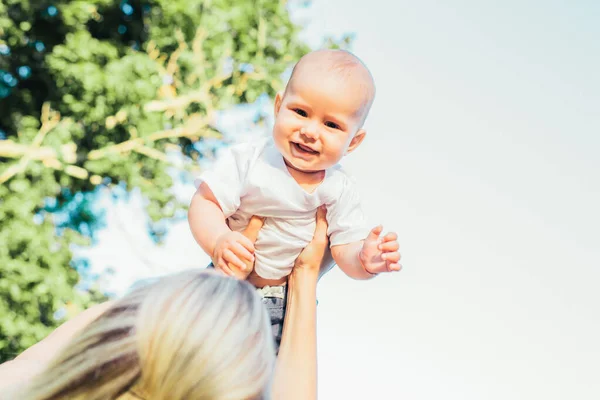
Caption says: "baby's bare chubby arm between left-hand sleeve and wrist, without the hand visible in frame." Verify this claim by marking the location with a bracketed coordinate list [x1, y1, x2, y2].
[188, 193, 230, 256]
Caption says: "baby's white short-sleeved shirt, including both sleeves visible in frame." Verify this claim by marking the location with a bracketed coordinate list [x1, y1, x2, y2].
[195, 138, 369, 279]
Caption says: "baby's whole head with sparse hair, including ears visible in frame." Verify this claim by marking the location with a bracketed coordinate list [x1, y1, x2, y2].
[273, 50, 375, 172]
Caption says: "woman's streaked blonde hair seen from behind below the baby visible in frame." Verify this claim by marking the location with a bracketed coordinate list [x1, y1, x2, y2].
[18, 270, 275, 400]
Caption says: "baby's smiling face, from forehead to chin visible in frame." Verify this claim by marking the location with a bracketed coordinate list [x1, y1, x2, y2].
[273, 68, 365, 172]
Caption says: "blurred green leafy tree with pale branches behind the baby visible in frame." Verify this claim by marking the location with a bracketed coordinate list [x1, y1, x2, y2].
[0, 0, 308, 362]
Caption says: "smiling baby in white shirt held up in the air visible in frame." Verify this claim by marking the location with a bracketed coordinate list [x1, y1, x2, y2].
[188, 50, 400, 346]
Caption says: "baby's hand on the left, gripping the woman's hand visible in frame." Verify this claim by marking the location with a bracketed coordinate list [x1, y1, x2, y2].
[212, 230, 255, 276]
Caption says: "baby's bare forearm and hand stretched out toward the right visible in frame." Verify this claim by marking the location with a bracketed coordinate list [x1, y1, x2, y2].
[331, 226, 401, 279]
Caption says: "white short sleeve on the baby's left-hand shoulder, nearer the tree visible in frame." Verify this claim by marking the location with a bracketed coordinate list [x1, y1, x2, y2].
[194, 143, 254, 218]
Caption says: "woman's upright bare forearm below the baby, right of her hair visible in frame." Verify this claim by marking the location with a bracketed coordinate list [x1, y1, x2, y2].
[273, 269, 318, 400]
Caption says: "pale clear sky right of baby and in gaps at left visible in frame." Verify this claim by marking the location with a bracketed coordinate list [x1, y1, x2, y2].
[81, 0, 600, 400]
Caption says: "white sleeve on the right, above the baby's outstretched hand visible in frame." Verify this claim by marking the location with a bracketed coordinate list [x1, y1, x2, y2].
[327, 179, 369, 246]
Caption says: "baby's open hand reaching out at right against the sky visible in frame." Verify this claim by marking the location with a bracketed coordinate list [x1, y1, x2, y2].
[358, 225, 402, 274]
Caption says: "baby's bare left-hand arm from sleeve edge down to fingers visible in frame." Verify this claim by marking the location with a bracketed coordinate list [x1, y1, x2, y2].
[188, 182, 254, 278]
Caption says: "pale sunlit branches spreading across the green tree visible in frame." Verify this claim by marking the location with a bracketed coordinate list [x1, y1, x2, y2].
[0, 29, 266, 184]
